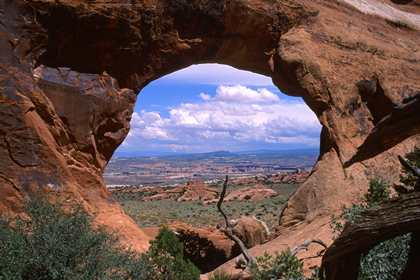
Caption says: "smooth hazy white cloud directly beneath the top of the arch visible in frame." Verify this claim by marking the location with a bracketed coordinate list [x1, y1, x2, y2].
[159, 64, 273, 86]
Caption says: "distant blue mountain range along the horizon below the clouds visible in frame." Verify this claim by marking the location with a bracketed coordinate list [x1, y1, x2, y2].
[113, 148, 319, 158]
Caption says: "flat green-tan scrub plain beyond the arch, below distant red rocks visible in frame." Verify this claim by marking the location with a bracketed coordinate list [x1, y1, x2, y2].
[113, 179, 300, 230]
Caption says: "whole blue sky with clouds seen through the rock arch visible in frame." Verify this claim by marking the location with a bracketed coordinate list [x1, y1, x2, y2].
[117, 64, 321, 153]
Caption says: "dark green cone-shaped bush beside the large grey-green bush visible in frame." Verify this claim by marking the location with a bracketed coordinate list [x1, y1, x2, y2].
[147, 226, 200, 280]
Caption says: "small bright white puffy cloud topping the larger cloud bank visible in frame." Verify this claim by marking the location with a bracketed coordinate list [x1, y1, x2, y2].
[199, 85, 280, 103]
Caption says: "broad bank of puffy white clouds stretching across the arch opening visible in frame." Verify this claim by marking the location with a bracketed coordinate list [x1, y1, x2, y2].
[127, 89, 321, 150]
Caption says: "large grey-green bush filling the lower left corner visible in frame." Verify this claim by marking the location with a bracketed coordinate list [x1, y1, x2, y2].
[0, 192, 149, 280]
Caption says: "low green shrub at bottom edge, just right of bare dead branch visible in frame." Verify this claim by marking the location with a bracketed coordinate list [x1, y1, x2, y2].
[250, 250, 305, 280]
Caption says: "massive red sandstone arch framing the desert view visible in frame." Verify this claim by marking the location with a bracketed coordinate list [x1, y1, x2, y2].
[0, 0, 420, 256]
